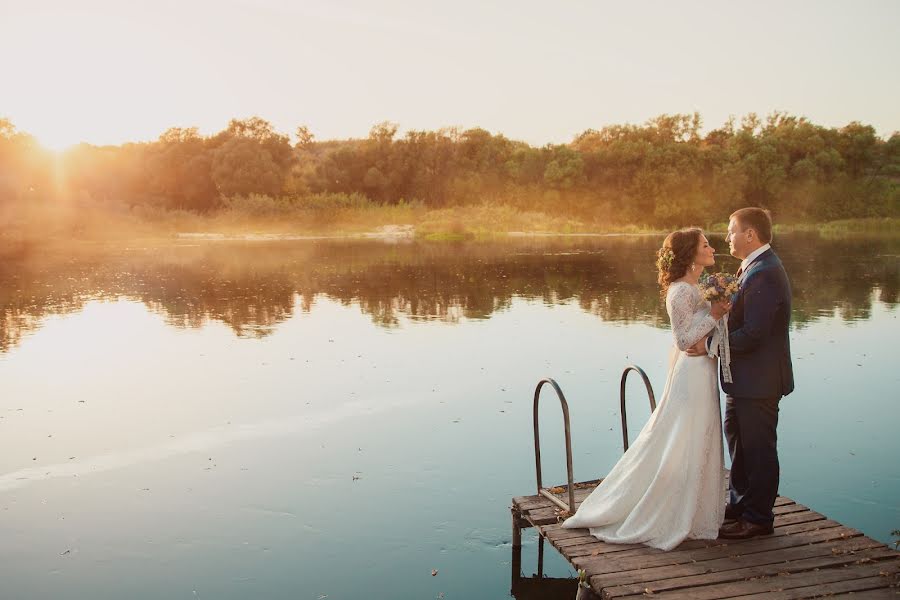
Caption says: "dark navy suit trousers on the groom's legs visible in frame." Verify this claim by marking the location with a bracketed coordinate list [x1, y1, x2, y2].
[725, 395, 781, 525]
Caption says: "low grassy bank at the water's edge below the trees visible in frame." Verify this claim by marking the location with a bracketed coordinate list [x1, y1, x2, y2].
[0, 195, 900, 252]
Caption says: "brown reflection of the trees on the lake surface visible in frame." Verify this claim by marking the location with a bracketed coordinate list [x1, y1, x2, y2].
[0, 235, 900, 351]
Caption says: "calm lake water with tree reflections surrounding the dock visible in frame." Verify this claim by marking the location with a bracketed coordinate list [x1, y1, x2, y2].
[0, 236, 900, 600]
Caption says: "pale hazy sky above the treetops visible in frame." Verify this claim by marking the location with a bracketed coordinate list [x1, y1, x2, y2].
[0, 0, 900, 148]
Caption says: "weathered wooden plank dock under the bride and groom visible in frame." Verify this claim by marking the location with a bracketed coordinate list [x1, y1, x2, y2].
[512, 481, 900, 600]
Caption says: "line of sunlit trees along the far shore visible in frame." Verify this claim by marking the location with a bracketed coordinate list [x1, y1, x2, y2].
[0, 113, 900, 226]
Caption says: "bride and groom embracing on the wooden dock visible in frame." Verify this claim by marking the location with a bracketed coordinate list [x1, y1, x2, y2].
[563, 208, 794, 550]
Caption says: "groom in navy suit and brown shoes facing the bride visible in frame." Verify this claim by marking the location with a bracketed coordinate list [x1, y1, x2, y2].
[694, 208, 794, 539]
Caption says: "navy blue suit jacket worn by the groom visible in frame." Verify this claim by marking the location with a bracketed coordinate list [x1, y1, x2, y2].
[720, 249, 794, 398]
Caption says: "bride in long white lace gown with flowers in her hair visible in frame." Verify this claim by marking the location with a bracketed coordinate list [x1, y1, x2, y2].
[563, 228, 730, 550]
